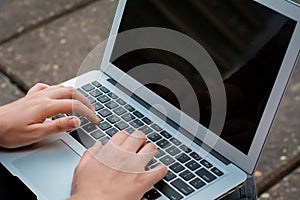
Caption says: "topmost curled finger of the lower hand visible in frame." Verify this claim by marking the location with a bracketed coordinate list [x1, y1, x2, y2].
[120, 131, 146, 152]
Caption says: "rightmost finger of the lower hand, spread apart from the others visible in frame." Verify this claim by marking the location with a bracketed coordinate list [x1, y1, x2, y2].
[143, 164, 168, 187]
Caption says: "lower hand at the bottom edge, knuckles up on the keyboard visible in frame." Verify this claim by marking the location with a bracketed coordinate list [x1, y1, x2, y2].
[70, 131, 167, 200]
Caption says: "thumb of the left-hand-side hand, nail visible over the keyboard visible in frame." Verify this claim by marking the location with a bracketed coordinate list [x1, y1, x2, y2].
[41, 116, 80, 135]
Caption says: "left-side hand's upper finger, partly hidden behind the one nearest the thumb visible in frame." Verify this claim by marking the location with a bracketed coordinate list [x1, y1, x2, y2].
[45, 85, 94, 110]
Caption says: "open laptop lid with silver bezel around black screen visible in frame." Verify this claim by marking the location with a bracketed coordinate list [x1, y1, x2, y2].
[101, 0, 300, 174]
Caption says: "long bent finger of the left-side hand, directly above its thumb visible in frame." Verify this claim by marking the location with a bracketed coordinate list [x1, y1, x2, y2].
[46, 99, 100, 123]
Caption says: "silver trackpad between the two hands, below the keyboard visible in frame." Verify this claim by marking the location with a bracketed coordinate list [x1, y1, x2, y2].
[13, 140, 80, 199]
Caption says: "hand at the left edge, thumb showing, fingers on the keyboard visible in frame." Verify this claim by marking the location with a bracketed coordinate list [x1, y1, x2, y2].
[0, 83, 100, 148]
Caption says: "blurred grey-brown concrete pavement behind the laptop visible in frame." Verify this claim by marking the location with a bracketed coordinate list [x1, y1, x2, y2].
[0, 0, 300, 200]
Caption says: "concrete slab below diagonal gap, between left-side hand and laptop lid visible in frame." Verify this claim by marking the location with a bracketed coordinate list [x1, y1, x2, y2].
[0, 0, 116, 90]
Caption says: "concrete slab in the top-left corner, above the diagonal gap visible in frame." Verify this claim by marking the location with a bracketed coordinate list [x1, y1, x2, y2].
[0, 0, 99, 44]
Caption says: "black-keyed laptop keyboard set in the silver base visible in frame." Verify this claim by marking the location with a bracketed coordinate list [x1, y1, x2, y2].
[53, 81, 224, 200]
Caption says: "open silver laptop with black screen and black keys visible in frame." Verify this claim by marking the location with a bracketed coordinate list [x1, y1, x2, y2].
[0, 0, 300, 200]
